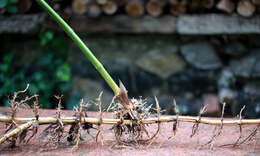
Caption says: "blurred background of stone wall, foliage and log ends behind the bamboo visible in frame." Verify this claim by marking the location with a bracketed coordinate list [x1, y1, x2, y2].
[0, 0, 260, 118]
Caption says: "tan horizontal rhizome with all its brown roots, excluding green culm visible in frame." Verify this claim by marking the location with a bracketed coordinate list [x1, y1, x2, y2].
[0, 85, 260, 149]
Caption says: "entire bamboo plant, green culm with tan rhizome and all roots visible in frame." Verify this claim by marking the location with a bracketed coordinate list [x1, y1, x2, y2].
[0, 0, 260, 150]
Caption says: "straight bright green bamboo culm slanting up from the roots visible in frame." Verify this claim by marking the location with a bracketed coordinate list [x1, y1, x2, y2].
[36, 0, 120, 95]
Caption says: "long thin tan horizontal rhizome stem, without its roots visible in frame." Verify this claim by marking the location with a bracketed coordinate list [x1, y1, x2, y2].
[0, 115, 260, 126]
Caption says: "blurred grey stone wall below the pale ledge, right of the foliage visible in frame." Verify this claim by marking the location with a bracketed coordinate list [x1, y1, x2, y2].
[65, 34, 260, 117]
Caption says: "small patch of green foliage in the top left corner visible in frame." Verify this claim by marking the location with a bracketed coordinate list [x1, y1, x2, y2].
[0, 0, 18, 14]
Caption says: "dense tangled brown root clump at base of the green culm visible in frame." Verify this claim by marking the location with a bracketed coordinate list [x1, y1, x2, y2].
[111, 84, 154, 147]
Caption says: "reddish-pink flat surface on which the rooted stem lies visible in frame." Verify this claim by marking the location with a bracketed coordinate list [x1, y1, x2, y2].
[0, 108, 260, 156]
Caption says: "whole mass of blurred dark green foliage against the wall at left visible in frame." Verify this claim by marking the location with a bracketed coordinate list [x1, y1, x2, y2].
[0, 30, 72, 108]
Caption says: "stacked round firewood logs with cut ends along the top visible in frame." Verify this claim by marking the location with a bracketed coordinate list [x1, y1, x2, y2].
[5, 0, 260, 17]
